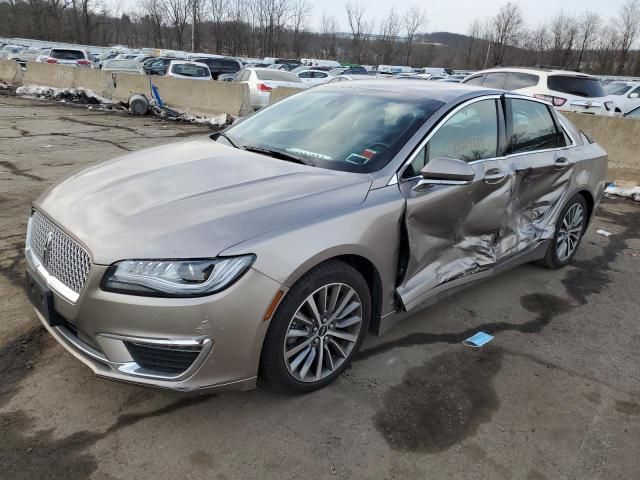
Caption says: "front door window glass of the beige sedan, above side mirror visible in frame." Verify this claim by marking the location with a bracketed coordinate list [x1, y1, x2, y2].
[403, 100, 498, 178]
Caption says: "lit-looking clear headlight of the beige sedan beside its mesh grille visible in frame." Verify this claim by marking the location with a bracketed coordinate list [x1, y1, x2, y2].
[101, 255, 256, 297]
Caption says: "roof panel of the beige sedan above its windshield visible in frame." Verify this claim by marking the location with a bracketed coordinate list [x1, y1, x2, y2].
[319, 78, 504, 103]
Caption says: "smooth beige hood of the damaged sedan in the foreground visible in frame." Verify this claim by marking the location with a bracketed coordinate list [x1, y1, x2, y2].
[34, 138, 371, 265]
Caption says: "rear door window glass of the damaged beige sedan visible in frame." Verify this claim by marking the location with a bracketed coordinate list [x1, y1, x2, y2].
[511, 99, 563, 153]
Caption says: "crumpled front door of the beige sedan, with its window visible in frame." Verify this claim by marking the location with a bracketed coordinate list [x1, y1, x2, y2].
[397, 95, 513, 310]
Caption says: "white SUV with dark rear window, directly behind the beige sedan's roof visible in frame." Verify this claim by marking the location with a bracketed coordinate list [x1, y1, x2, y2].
[462, 68, 613, 115]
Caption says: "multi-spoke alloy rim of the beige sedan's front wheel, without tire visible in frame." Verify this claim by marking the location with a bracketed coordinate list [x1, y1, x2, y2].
[283, 283, 362, 382]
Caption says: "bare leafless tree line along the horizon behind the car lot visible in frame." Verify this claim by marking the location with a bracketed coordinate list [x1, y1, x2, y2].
[0, 0, 640, 75]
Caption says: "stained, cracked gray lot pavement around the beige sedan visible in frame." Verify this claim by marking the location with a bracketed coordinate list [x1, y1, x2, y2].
[0, 95, 640, 480]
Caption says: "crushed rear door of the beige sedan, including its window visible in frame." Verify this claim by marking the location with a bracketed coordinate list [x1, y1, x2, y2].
[504, 97, 574, 256]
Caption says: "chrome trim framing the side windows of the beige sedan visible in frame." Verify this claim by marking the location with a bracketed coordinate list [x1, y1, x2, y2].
[396, 93, 577, 185]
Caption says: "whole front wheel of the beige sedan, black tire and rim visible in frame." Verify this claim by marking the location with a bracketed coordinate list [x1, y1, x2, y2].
[260, 260, 371, 393]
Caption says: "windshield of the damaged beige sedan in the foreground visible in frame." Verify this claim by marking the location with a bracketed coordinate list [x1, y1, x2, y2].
[225, 87, 442, 173]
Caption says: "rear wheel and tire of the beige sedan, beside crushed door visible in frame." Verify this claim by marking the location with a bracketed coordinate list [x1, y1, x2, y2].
[540, 194, 588, 269]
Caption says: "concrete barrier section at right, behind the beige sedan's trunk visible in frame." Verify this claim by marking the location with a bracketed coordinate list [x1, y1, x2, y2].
[564, 113, 640, 184]
